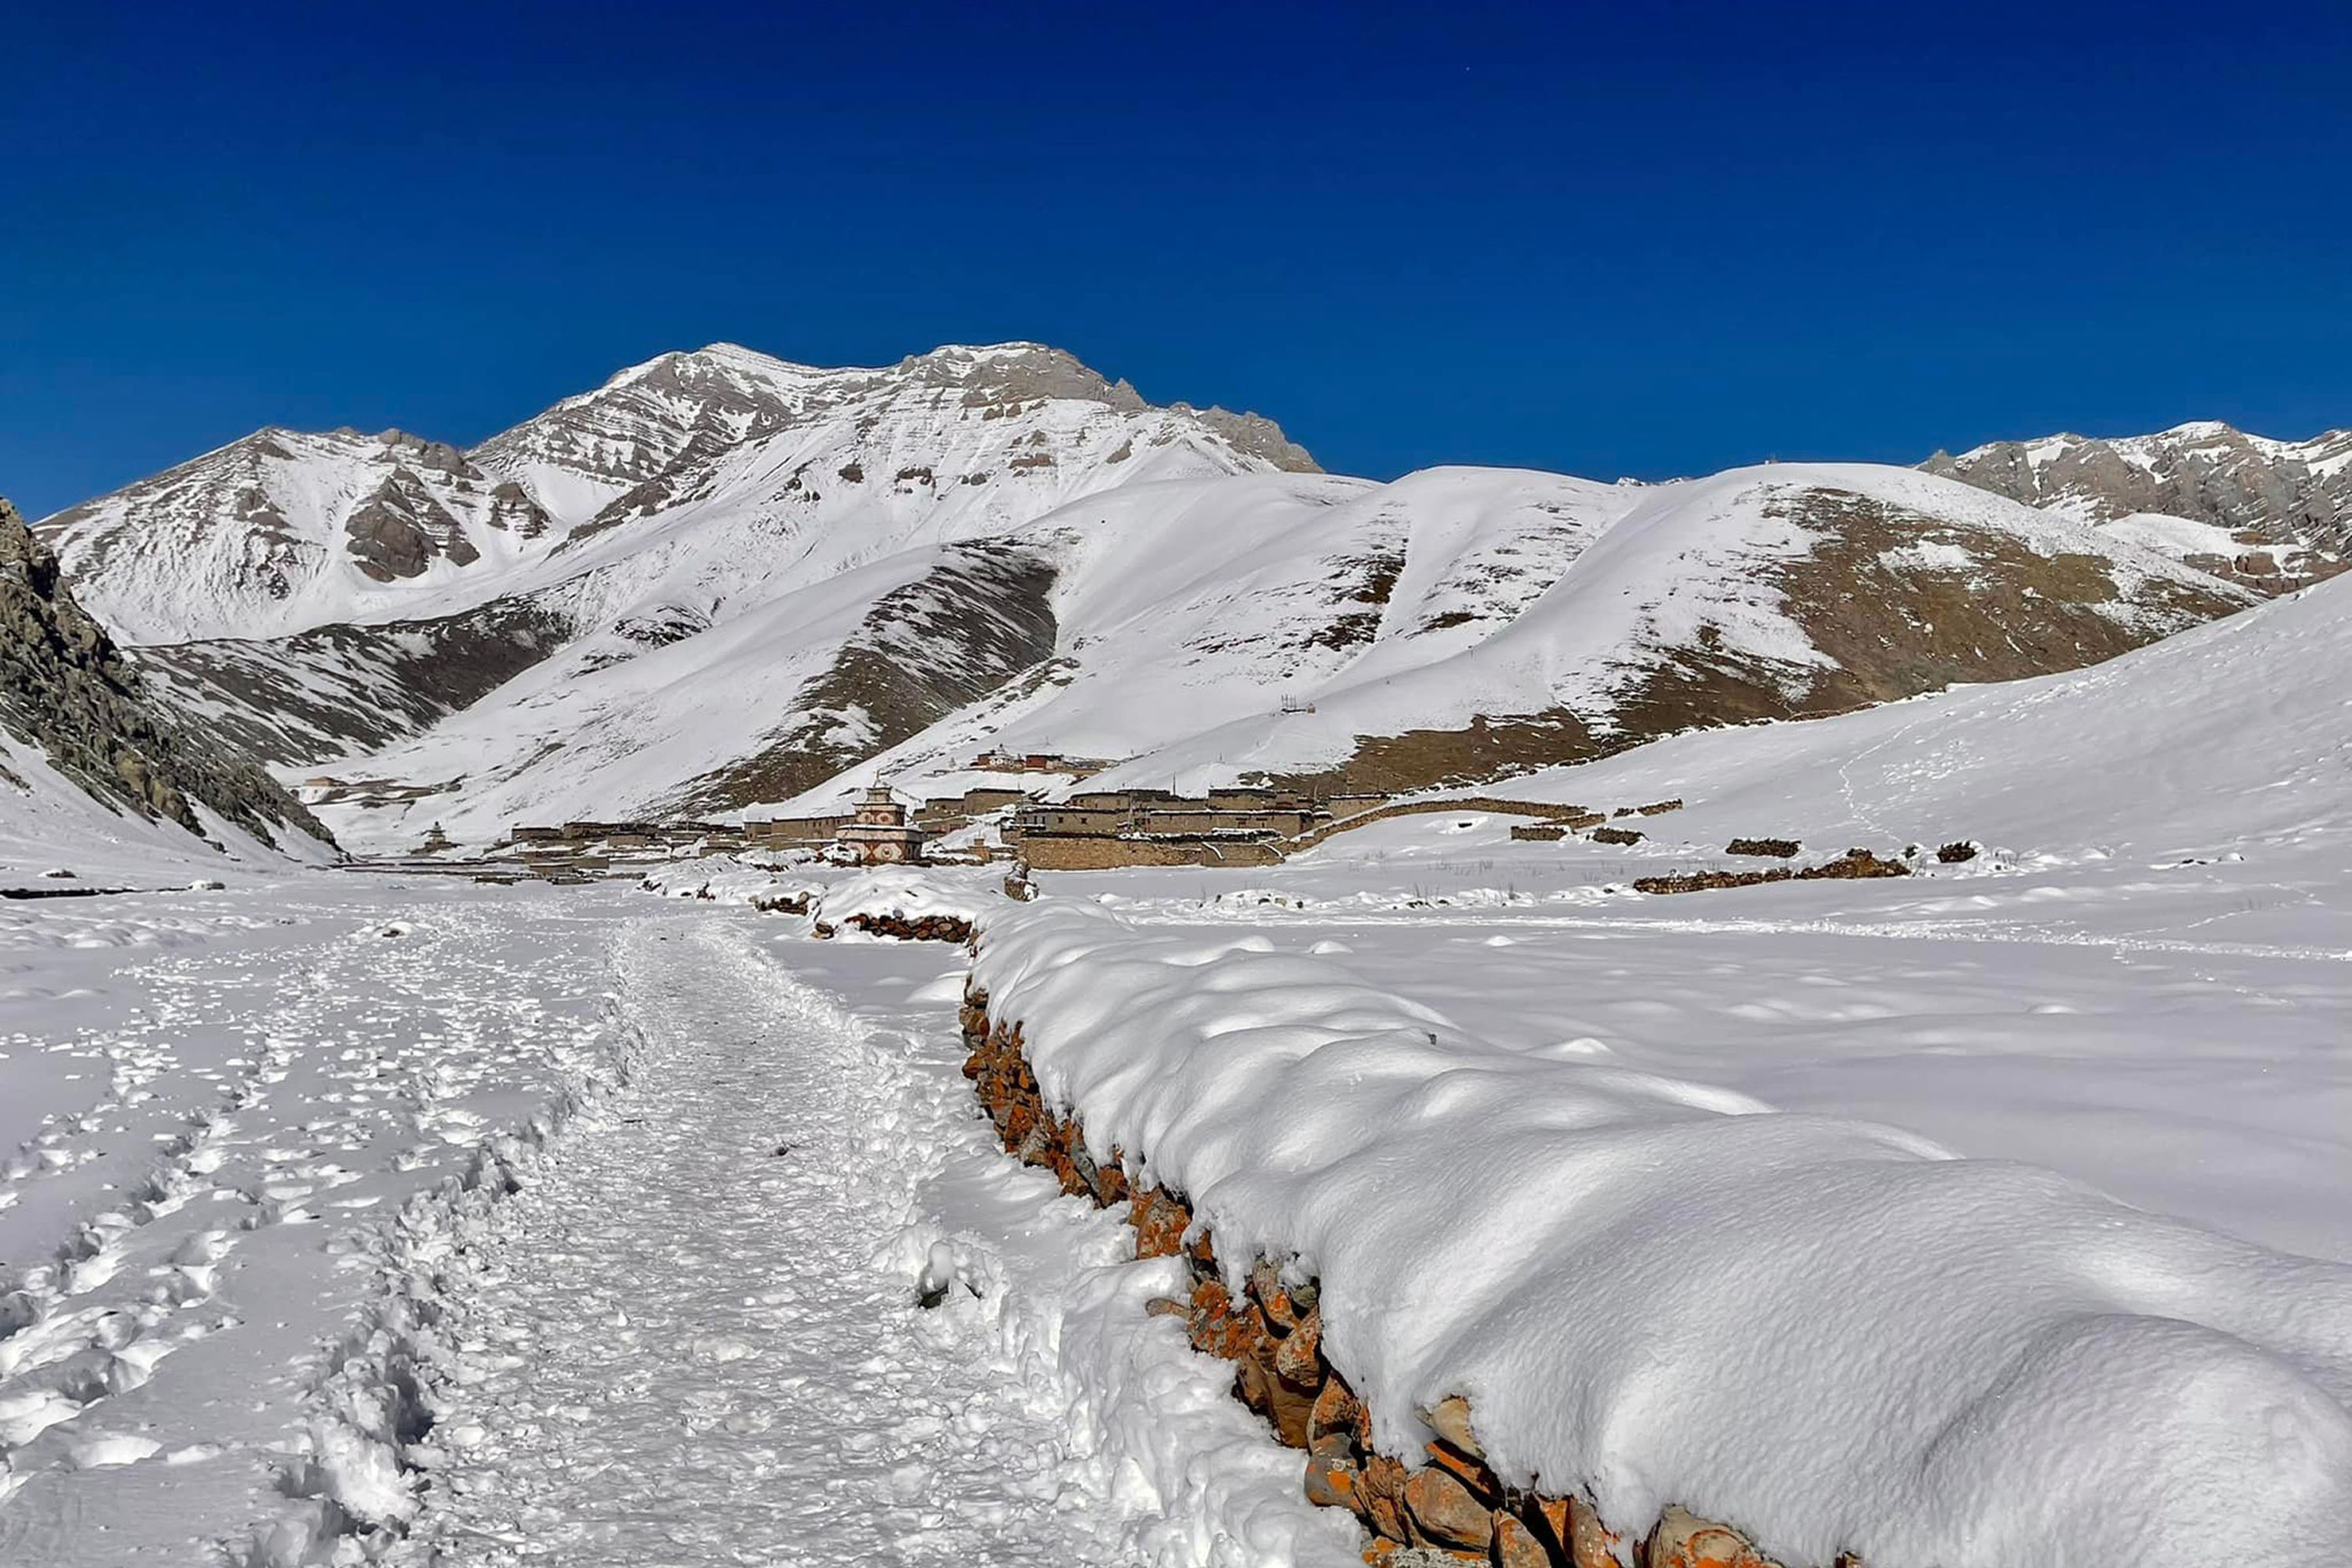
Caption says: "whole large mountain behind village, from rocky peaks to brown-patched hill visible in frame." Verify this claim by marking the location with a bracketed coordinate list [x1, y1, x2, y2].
[42, 343, 2253, 846]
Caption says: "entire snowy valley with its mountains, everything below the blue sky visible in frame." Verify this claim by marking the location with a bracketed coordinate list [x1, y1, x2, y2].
[0, 343, 2352, 1568]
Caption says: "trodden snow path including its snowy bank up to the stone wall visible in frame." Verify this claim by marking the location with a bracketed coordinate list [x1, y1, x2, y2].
[404, 915, 1355, 1568]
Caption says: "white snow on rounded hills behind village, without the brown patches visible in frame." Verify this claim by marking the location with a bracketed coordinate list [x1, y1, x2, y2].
[303, 453, 2213, 849]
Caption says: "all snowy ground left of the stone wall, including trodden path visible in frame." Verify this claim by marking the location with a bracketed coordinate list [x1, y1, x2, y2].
[0, 875, 1355, 1568]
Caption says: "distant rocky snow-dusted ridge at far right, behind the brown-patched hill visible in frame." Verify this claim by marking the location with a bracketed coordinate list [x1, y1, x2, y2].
[1921, 421, 2352, 593]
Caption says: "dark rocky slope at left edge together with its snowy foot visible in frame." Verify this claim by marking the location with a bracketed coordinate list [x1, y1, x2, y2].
[0, 500, 332, 877]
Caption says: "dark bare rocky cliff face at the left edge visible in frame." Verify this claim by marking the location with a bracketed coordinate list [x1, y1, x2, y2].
[0, 500, 332, 841]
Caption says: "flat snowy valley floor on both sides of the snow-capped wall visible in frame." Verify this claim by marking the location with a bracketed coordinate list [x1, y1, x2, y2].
[0, 851, 2352, 1568]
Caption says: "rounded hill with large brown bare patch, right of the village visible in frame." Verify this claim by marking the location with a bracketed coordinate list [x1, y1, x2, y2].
[1058, 453, 2244, 790]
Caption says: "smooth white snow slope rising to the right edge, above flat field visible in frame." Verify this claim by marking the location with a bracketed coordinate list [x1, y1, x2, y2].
[1467, 561, 2352, 858]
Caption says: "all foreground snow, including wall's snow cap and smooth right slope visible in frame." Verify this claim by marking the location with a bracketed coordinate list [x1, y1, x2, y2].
[0, 585, 2352, 1568]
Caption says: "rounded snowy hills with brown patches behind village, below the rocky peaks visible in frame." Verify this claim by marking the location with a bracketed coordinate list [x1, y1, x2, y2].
[257, 456, 2251, 841]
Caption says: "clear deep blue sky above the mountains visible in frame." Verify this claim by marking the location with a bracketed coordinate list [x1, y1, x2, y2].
[0, 0, 2352, 515]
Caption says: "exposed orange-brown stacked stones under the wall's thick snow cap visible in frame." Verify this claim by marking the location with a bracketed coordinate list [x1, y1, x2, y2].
[962, 990, 1861, 1568]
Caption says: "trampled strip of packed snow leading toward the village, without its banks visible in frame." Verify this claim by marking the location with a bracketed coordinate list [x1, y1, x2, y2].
[409, 919, 1138, 1568]
